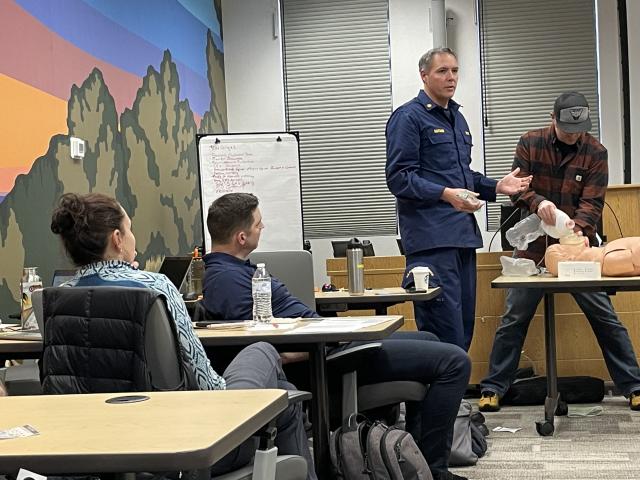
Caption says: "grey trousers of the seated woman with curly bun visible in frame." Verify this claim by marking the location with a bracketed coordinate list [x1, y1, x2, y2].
[212, 342, 317, 480]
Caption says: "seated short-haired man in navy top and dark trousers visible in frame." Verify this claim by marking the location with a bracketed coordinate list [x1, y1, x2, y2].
[203, 193, 471, 480]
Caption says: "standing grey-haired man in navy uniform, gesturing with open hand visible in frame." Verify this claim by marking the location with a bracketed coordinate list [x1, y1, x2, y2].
[386, 48, 531, 350]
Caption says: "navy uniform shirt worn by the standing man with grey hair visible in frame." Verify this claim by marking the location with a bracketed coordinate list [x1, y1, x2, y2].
[386, 90, 497, 255]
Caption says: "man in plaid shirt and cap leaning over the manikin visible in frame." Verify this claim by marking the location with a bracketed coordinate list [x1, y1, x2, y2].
[479, 92, 640, 411]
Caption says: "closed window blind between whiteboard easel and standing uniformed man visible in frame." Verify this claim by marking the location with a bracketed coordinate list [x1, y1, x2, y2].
[281, 0, 396, 238]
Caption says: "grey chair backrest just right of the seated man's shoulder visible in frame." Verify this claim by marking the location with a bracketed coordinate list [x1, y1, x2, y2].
[249, 250, 316, 310]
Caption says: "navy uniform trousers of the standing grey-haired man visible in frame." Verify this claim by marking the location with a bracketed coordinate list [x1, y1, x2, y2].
[402, 248, 476, 351]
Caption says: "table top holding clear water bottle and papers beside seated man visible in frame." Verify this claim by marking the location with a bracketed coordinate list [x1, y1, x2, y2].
[196, 315, 404, 346]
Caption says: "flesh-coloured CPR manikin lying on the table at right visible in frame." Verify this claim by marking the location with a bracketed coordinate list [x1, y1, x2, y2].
[544, 237, 640, 277]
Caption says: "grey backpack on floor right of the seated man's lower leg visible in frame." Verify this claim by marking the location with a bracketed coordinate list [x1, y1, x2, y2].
[449, 400, 489, 467]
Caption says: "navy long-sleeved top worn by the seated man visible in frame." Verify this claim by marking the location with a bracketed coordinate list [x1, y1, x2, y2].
[202, 252, 318, 320]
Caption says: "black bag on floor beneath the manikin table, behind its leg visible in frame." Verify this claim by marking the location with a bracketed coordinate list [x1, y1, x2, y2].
[500, 376, 604, 405]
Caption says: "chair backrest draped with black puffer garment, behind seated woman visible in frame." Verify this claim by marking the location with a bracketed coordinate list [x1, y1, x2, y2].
[41, 286, 195, 393]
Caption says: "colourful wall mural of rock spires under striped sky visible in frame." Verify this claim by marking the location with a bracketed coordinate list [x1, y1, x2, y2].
[0, 0, 227, 321]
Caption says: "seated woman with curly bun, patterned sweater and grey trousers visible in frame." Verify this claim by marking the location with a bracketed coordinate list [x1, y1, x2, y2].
[51, 193, 316, 479]
